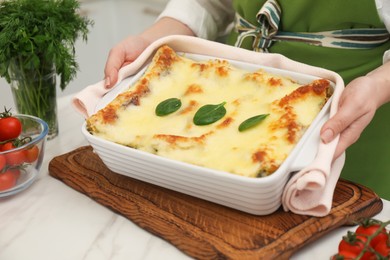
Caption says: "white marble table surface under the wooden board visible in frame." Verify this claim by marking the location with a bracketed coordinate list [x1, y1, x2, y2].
[0, 96, 390, 260]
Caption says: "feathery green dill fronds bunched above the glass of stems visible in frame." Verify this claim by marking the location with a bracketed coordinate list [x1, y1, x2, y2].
[0, 0, 93, 90]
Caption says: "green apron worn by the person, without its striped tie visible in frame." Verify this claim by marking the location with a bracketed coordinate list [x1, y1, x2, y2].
[227, 0, 390, 200]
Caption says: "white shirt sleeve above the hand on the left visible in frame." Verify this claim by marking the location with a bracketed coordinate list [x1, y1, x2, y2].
[157, 0, 234, 40]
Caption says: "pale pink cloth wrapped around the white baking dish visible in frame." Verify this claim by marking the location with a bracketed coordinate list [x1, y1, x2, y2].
[72, 35, 344, 216]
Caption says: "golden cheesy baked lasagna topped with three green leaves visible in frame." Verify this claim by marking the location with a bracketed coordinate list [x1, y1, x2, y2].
[87, 46, 331, 177]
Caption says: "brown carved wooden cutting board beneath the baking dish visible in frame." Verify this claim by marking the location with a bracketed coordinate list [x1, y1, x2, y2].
[49, 146, 382, 259]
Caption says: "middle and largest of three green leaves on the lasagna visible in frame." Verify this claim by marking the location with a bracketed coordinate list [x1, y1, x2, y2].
[193, 102, 226, 125]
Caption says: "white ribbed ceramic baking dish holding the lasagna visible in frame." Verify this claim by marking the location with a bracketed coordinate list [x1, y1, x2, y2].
[82, 53, 334, 215]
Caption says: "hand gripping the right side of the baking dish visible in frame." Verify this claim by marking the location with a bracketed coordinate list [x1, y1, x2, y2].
[321, 63, 390, 158]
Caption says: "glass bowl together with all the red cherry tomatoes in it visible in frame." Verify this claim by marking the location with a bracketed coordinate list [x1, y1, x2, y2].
[0, 110, 49, 197]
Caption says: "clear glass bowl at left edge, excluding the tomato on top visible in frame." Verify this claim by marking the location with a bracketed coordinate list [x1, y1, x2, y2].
[0, 115, 49, 197]
